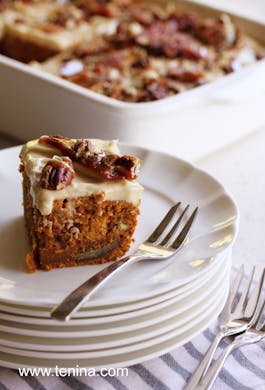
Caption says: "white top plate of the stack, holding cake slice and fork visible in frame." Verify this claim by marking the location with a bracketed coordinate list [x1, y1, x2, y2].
[0, 145, 238, 307]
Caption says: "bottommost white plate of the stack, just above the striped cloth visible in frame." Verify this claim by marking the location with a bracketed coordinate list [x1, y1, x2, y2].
[0, 284, 227, 370]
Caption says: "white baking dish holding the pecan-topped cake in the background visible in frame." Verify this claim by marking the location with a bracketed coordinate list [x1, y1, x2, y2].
[0, 0, 265, 160]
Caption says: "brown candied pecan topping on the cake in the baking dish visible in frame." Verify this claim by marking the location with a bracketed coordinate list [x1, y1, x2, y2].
[0, 0, 258, 103]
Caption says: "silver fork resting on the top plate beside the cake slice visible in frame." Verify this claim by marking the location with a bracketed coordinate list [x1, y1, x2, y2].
[51, 202, 198, 321]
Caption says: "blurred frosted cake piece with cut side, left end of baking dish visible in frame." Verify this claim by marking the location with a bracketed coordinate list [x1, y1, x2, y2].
[1, 1, 91, 62]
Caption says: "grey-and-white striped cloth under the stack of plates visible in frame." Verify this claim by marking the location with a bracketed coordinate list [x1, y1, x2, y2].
[0, 269, 265, 390]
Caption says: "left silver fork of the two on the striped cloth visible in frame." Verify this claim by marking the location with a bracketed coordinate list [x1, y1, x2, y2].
[185, 265, 265, 390]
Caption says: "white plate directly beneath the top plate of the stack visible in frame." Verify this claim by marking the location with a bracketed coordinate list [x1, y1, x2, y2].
[0, 250, 229, 327]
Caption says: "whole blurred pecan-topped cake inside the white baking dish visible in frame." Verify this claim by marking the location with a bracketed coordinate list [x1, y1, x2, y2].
[0, 0, 264, 103]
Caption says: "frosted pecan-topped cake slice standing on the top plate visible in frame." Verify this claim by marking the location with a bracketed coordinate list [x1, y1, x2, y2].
[20, 136, 143, 272]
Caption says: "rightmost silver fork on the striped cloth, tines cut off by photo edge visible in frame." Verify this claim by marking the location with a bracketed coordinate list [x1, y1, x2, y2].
[198, 290, 265, 390]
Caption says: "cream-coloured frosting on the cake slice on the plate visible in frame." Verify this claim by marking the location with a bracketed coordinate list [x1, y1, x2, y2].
[20, 139, 143, 215]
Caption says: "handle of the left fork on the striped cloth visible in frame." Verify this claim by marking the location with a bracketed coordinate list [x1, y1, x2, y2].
[185, 330, 225, 390]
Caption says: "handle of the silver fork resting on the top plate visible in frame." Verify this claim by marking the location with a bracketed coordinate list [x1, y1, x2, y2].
[51, 253, 142, 321]
